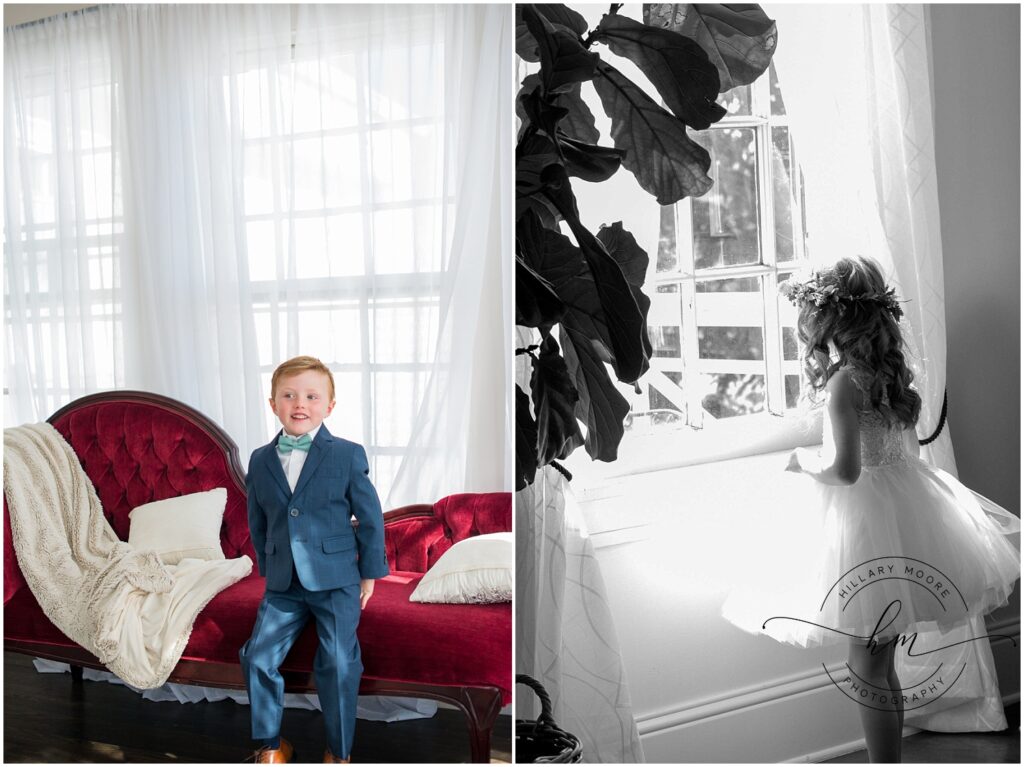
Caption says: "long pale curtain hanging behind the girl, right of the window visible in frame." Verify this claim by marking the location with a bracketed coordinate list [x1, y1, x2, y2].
[766, 4, 1006, 731]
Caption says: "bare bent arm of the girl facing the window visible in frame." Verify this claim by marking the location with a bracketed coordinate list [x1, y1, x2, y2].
[786, 370, 860, 484]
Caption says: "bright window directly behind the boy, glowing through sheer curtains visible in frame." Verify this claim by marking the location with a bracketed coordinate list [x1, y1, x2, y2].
[232, 28, 454, 486]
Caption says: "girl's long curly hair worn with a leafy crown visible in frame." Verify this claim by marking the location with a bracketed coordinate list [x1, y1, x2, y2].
[797, 256, 921, 427]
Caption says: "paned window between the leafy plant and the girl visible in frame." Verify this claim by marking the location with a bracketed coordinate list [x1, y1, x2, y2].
[629, 68, 807, 430]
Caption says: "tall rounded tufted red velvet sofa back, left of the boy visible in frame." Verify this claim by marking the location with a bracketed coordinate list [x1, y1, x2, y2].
[50, 391, 256, 561]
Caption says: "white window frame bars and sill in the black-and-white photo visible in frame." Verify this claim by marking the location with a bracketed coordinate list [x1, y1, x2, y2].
[568, 67, 821, 485]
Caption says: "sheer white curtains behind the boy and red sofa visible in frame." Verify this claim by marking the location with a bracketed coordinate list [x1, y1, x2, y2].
[4, 4, 512, 505]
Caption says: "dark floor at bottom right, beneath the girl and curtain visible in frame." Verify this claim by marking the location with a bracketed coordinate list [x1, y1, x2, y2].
[826, 704, 1021, 764]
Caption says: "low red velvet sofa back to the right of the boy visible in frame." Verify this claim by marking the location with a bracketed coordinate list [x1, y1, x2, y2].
[385, 493, 512, 572]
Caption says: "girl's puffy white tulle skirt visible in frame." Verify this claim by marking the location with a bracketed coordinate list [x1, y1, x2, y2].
[722, 458, 1020, 647]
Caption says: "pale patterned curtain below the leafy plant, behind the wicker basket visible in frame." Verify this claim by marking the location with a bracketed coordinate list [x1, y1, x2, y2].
[515, 328, 644, 764]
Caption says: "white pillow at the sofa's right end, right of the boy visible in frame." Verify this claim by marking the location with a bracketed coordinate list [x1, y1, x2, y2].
[409, 532, 515, 604]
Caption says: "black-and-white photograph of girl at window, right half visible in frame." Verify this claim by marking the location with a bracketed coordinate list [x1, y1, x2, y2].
[515, 3, 1021, 764]
